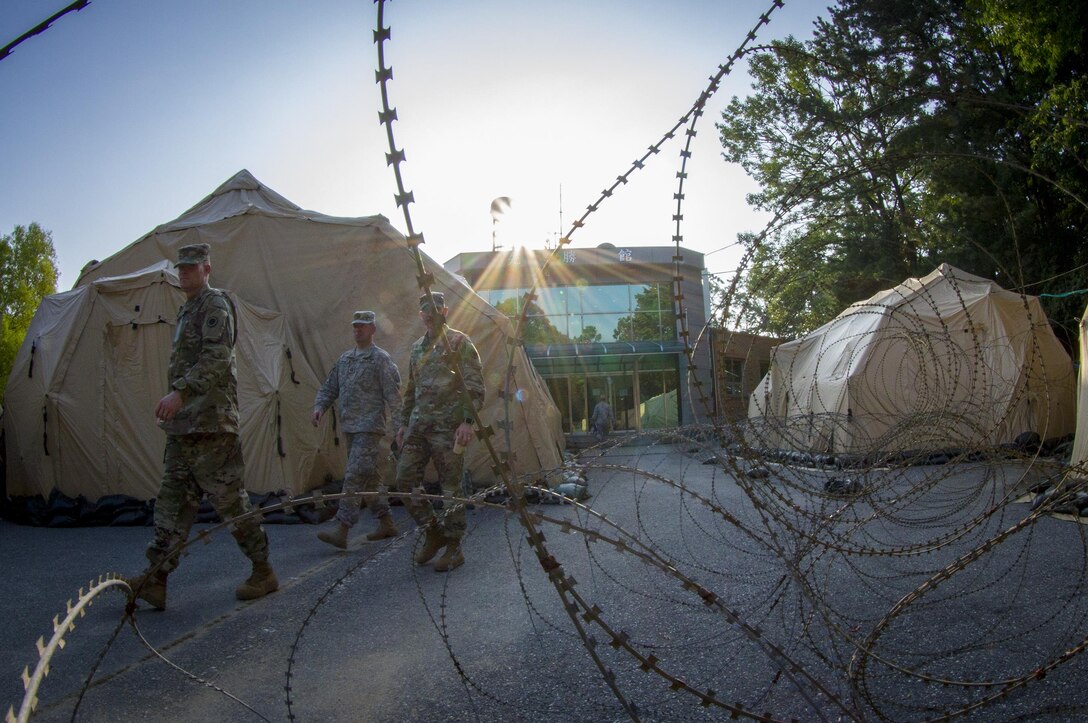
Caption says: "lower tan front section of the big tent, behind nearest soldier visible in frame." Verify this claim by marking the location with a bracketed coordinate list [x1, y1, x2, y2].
[7, 261, 330, 499]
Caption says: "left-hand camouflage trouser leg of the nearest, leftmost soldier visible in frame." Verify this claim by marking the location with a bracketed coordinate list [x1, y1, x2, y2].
[147, 435, 200, 574]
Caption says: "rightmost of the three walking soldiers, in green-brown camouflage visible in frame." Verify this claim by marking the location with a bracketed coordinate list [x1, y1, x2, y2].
[396, 291, 484, 572]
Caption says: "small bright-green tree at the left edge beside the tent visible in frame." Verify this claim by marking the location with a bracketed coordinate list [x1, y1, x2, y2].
[0, 223, 57, 402]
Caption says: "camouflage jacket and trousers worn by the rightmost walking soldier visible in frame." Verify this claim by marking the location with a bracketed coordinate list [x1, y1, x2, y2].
[396, 319, 484, 540]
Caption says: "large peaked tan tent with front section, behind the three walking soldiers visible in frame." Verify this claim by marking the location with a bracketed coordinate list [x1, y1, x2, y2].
[4, 171, 564, 499]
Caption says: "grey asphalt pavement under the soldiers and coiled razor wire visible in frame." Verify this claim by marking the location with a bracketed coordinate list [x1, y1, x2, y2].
[0, 446, 1088, 721]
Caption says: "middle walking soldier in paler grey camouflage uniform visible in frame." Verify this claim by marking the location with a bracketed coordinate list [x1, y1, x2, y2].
[311, 311, 400, 550]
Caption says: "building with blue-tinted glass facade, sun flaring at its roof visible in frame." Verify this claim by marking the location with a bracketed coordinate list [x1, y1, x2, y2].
[445, 245, 715, 434]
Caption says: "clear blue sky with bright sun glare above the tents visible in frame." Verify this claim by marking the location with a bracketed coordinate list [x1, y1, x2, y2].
[0, 0, 828, 290]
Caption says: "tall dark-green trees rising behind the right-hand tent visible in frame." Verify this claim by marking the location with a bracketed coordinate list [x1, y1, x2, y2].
[718, 0, 1088, 343]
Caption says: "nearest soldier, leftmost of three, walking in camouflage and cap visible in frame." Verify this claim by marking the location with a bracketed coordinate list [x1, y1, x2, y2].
[123, 244, 280, 610]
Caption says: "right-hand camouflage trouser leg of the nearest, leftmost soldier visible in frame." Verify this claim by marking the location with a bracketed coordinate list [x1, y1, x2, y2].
[193, 434, 269, 563]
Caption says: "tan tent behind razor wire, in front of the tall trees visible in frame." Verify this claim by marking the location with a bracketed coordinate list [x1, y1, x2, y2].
[749, 264, 1075, 453]
